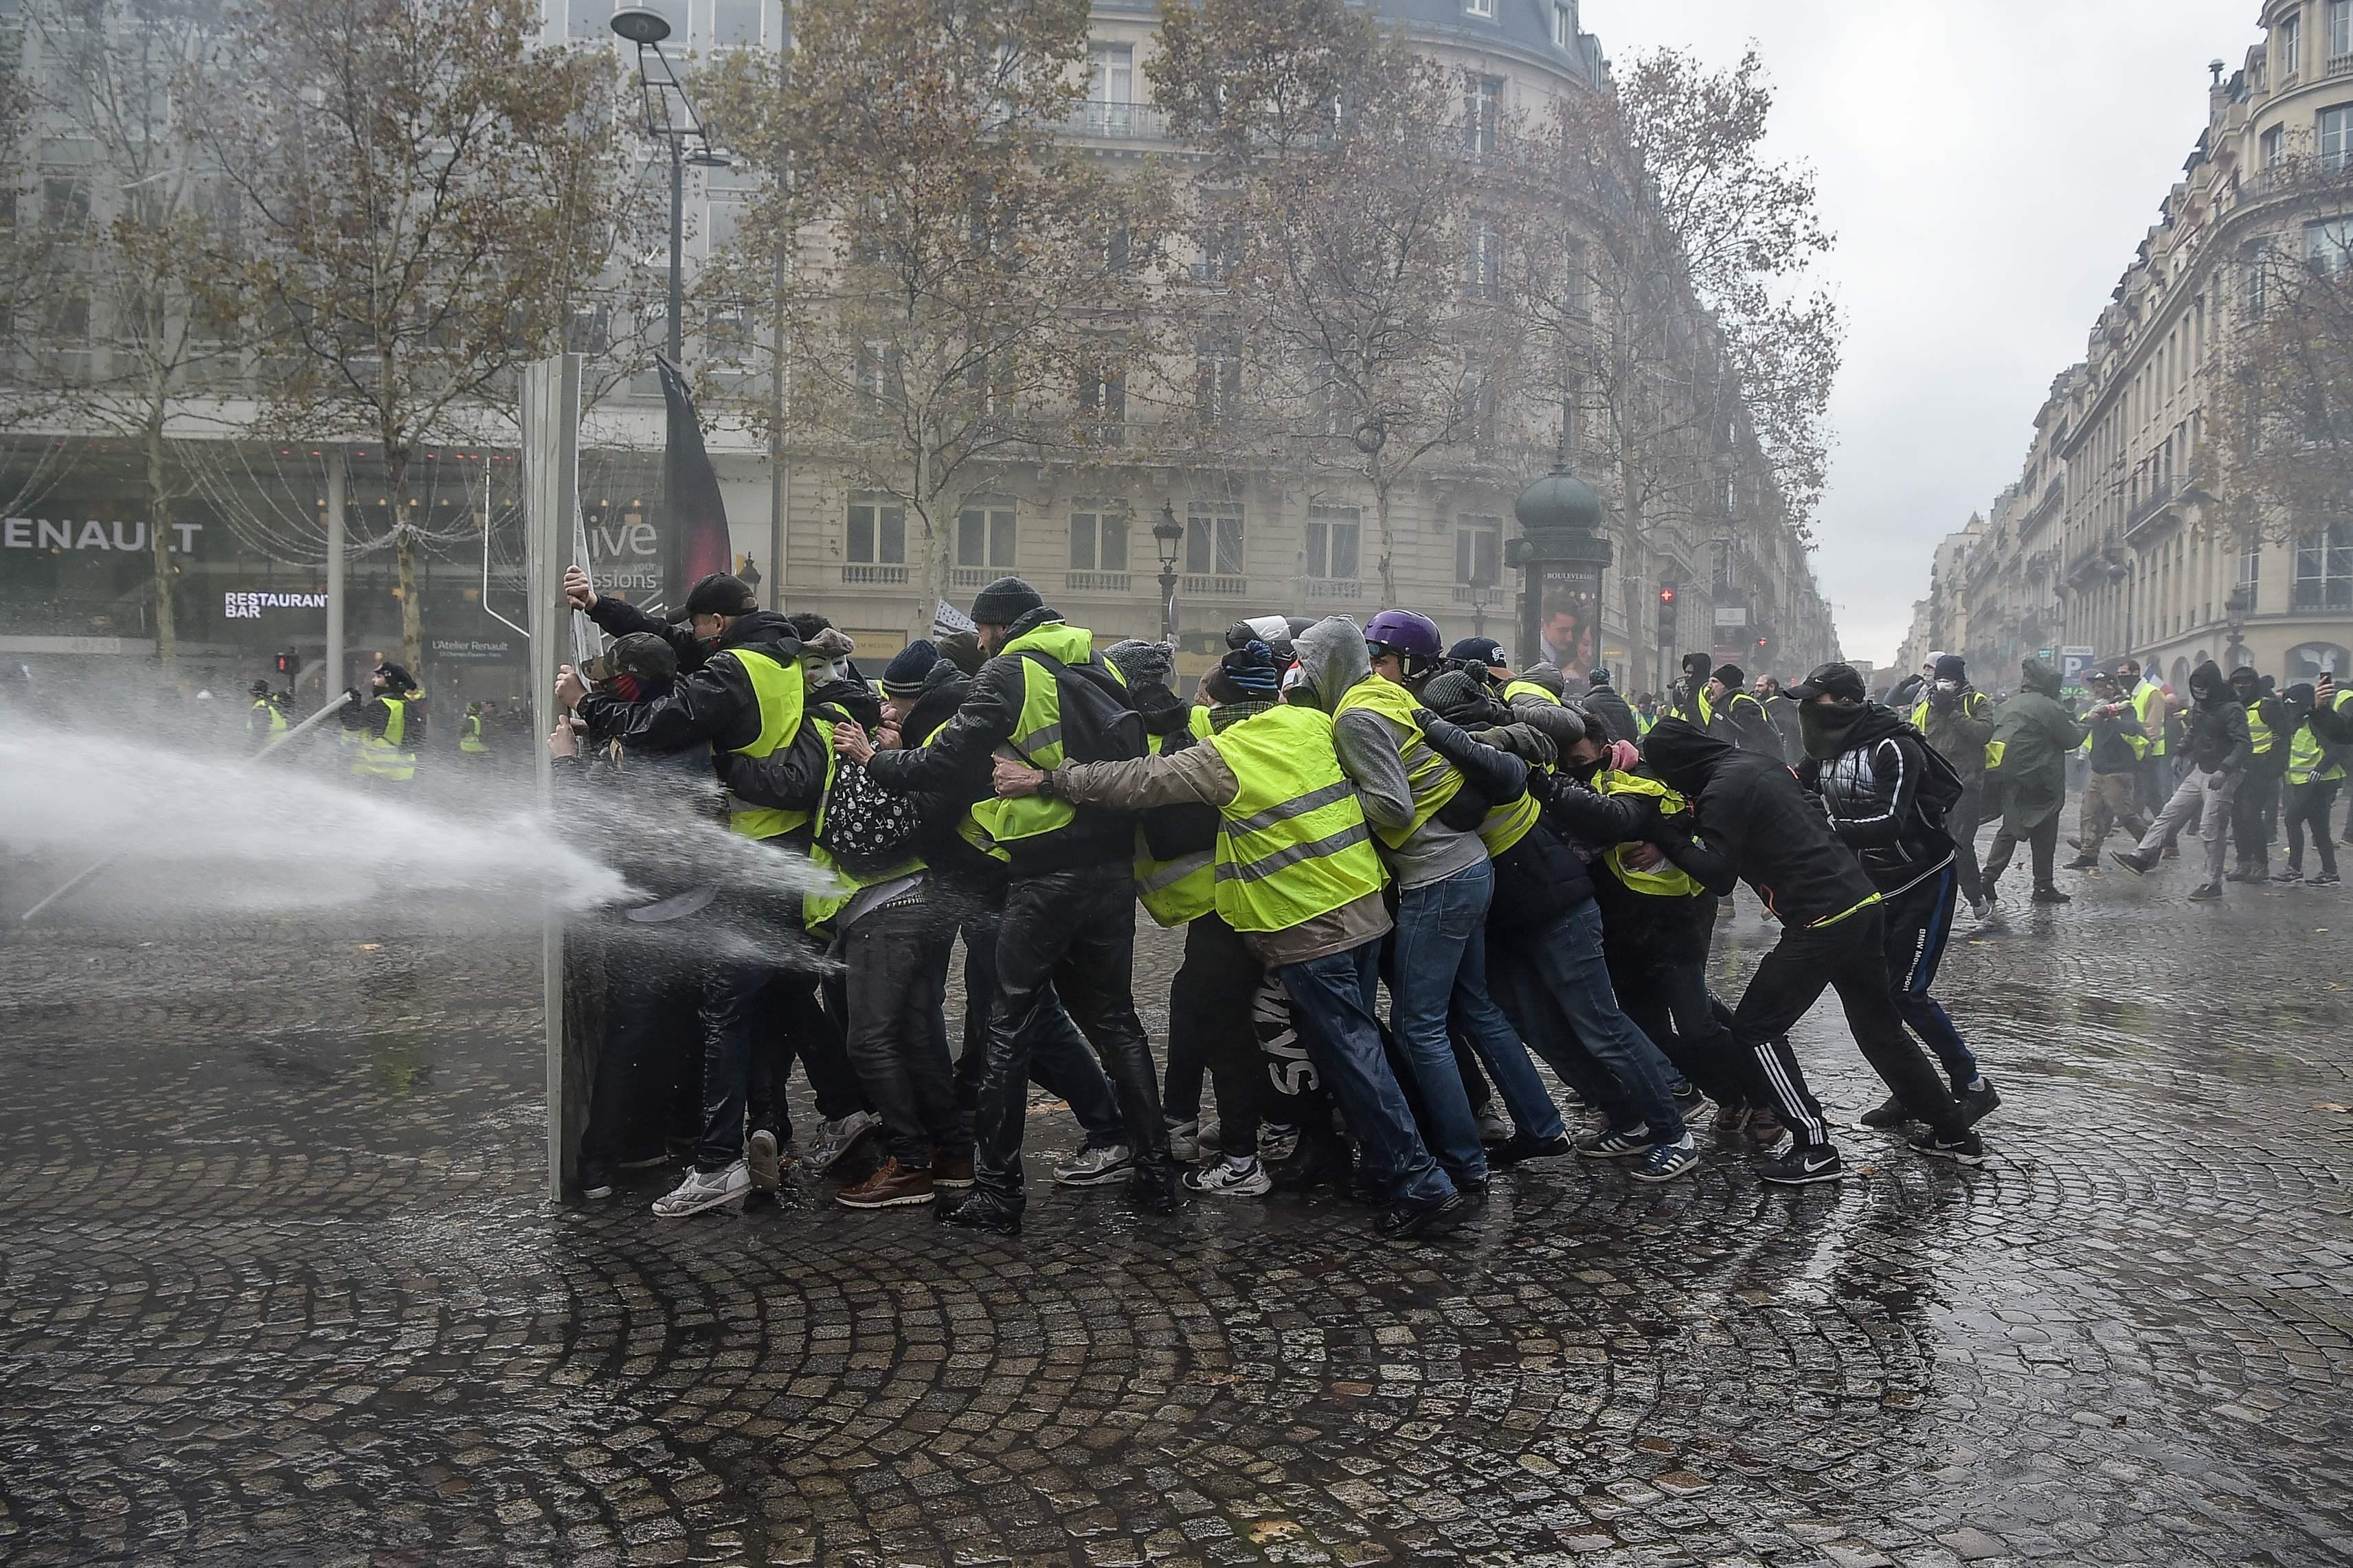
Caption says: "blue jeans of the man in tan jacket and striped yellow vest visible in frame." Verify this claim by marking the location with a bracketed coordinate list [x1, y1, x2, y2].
[1271, 943, 1449, 1203]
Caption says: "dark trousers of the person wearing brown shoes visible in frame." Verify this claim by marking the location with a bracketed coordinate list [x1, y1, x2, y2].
[837, 902, 965, 1168]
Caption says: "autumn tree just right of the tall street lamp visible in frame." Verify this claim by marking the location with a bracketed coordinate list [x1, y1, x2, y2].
[701, 0, 1162, 633]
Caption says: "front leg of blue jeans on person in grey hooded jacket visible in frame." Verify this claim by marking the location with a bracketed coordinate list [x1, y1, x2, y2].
[1388, 861, 1506, 1183]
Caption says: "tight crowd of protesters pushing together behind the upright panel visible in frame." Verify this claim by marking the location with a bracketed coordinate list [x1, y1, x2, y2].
[529, 569, 2000, 1236]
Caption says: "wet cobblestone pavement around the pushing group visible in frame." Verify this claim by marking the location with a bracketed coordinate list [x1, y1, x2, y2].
[0, 874, 2353, 1568]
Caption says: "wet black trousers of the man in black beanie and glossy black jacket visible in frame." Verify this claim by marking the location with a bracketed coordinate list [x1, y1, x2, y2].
[972, 861, 1169, 1208]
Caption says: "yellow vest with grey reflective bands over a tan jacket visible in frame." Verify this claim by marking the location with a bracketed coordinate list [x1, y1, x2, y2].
[1202, 700, 1384, 931]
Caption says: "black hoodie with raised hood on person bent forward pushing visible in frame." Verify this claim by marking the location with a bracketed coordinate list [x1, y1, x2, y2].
[1643, 719, 1878, 927]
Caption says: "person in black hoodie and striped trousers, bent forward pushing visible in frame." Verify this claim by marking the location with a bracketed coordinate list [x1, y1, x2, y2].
[1643, 719, 1986, 1188]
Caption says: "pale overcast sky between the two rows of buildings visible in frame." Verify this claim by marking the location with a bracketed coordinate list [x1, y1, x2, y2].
[1584, 0, 2259, 679]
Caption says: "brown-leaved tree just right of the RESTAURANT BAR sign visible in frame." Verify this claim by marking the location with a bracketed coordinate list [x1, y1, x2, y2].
[205, 0, 642, 670]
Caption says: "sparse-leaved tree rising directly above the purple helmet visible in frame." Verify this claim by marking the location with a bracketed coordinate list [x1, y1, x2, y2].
[1151, 0, 1529, 602]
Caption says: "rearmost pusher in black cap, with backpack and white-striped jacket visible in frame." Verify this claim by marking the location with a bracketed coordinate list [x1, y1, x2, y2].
[1790, 663, 2003, 1128]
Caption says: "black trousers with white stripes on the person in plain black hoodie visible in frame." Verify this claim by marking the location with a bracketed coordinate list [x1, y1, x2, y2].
[1732, 902, 1967, 1147]
